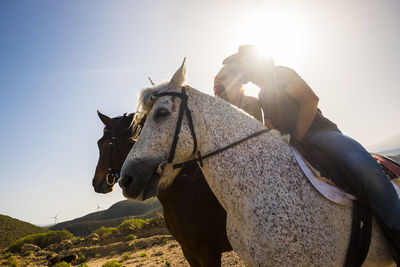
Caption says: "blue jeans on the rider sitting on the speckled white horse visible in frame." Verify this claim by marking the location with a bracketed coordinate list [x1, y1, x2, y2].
[302, 129, 400, 231]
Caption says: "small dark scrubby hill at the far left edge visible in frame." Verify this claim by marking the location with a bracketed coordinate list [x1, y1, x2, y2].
[0, 214, 47, 249]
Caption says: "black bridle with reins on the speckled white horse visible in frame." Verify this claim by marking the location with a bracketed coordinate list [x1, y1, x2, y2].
[155, 86, 270, 169]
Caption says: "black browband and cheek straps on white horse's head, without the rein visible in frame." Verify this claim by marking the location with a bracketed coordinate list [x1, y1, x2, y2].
[156, 86, 197, 163]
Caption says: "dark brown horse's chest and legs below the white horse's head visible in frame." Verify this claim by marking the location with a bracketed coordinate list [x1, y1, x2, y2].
[158, 164, 232, 267]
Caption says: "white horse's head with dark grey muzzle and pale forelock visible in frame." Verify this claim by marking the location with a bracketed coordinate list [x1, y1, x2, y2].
[119, 60, 200, 200]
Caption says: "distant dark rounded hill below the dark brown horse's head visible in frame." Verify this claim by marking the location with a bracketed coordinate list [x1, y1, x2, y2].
[49, 198, 162, 236]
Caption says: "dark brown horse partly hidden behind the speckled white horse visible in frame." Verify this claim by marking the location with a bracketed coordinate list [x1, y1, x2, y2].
[93, 112, 232, 266]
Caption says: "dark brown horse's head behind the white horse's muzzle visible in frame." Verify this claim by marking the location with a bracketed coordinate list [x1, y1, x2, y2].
[92, 111, 134, 194]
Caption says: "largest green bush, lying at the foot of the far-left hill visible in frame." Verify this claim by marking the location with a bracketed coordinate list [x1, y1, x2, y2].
[7, 230, 74, 253]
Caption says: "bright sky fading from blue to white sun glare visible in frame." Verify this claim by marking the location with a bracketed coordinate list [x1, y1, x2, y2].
[0, 0, 400, 224]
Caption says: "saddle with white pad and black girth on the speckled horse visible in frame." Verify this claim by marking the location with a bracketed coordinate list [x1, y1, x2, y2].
[292, 143, 400, 266]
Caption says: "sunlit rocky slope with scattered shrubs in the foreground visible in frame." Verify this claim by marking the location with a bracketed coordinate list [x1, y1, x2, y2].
[0, 216, 247, 267]
